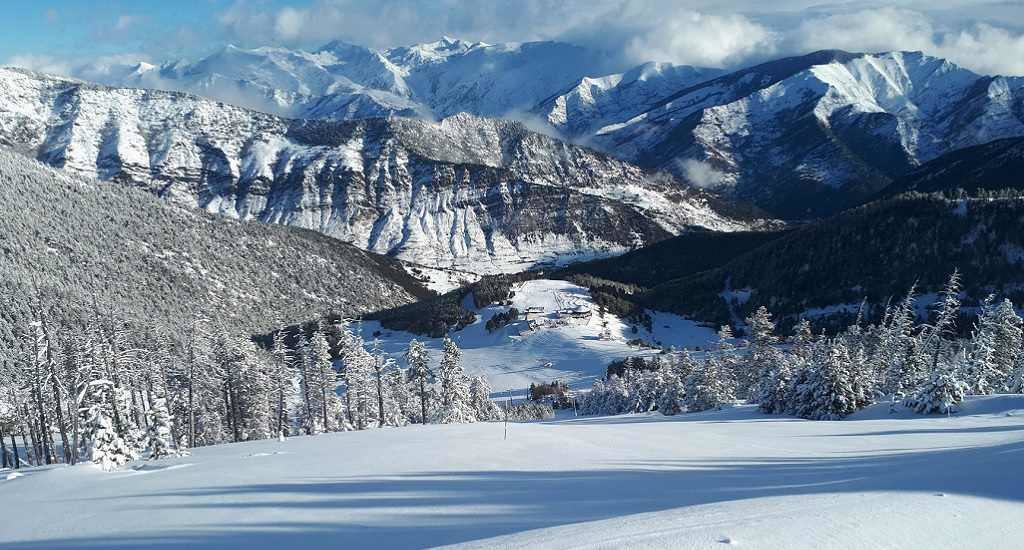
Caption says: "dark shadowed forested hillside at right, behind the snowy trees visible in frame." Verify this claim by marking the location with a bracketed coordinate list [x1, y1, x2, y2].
[637, 194, 1024, 334]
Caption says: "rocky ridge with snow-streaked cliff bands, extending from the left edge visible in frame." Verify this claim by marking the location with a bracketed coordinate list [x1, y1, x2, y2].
[0, 68, 757, 272]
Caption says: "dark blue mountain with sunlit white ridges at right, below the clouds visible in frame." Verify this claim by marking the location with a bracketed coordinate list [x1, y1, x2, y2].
[591, 51, 1024, 216]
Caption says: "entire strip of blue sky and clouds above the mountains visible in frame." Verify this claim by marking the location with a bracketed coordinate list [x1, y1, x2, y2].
[6, 0, 1024, 78]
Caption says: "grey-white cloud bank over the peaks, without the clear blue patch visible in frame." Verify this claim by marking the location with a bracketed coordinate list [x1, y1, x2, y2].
[6, 0, 1024, 78]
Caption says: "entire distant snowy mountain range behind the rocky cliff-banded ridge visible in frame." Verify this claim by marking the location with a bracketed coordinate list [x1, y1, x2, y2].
[79, 38, 1024, 218]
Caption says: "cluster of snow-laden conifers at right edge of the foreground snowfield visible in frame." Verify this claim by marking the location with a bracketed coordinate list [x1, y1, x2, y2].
[582, 272, 1024, 420]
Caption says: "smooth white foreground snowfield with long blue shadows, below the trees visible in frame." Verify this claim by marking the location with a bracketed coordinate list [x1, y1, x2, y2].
[0, 396, 1024, 549]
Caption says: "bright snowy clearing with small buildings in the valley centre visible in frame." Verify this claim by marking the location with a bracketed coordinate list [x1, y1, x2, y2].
[361, 280, 717, 395]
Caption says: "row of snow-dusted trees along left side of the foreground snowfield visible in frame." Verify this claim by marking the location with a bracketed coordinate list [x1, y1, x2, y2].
[0, 300, 550, 469]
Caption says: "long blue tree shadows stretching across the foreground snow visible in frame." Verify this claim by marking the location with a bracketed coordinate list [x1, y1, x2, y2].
[4, 433, 1024, 550]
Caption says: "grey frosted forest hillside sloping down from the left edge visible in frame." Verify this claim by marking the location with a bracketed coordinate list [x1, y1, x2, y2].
[0, 150, 430, 341]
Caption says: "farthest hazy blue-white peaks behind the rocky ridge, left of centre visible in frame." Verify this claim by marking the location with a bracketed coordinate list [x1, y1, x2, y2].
[98, 37, 622, 120]
